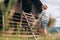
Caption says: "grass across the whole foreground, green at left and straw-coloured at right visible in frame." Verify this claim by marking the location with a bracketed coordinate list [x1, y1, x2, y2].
[0, 33, 60, 40]
